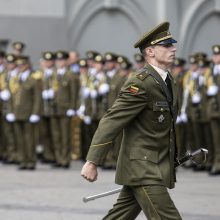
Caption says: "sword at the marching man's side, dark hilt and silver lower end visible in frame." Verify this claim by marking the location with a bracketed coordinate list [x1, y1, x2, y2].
[83, 148, 208, 202]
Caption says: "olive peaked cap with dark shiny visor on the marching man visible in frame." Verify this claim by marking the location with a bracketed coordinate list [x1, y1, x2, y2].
[134, 22, 177, 50]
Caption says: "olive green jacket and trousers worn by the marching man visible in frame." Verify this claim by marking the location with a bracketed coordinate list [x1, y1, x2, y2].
[87, 65, 181, 219]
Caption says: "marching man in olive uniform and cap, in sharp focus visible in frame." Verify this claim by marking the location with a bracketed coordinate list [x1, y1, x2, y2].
[81, 22, 182, 220]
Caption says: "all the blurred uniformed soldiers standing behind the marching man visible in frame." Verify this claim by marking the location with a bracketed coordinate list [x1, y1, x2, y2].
[0, 42, 220, 175]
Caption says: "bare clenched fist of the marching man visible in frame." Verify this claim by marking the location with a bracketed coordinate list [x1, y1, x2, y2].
[81, 161, 98, 182]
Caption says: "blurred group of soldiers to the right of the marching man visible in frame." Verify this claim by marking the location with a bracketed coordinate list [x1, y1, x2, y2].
[172, 45, 220, 175]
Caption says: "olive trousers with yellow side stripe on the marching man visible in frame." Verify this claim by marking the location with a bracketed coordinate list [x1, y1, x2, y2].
[103, 185, 182, 220]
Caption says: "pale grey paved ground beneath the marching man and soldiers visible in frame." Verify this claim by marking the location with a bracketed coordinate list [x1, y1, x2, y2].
[0, 161, 220, 220]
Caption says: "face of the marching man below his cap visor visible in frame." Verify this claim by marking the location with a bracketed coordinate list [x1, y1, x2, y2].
[153, 44, 176, 66]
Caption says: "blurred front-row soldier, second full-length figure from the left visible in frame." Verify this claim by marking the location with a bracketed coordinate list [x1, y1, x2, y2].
[51, 51, 80, 168]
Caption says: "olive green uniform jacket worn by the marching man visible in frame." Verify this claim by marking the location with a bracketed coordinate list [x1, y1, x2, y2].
[87, 64, 177, 188]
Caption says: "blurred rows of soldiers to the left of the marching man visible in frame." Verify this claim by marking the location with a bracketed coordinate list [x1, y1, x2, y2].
[0, 42, 144, 170]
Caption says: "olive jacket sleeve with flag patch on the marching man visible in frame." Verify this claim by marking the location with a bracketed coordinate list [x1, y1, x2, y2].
[87, 76, 147, 165]
